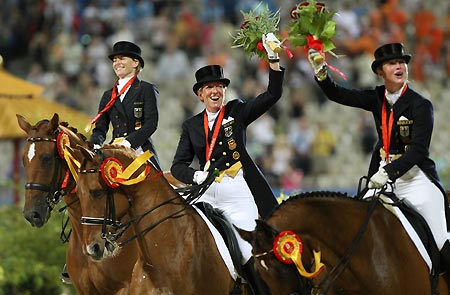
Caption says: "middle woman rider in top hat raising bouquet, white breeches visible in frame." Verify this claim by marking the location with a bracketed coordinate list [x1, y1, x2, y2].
[171, 33, 284, 295]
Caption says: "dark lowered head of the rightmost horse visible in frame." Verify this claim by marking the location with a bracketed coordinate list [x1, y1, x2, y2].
[236, 219, 310, 295]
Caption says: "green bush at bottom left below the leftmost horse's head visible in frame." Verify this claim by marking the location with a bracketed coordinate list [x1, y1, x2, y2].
[0, 205, 76, 295]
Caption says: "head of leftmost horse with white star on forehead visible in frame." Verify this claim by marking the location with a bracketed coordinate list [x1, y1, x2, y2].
[16, 113, 88, 227]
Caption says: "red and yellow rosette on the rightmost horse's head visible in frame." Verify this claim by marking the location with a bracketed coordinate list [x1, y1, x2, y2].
[273, 231, 325, 279]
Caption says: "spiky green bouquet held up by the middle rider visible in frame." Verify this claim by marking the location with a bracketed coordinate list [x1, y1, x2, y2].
[231, 2, 280, 60]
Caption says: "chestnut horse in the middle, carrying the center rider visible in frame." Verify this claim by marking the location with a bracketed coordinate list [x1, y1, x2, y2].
[77, 145, 250, 295]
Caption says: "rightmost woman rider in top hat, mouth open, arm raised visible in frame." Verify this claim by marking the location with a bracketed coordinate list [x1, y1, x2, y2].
[308, 43, 450, 271]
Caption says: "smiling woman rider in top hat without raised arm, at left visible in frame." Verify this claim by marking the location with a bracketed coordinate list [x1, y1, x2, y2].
[90, 41, 161, 169]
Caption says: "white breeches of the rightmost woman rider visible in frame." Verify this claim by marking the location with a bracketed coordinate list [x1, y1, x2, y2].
[368, 162, 448, 250]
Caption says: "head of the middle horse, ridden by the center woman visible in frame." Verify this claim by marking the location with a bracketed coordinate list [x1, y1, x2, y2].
[77, 145, 142, 260]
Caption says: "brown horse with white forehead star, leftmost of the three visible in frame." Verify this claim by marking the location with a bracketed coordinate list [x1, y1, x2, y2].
[16, 114, 137, 295]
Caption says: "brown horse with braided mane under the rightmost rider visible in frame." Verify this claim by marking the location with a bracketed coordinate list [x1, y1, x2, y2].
[238, 192, 449, 295]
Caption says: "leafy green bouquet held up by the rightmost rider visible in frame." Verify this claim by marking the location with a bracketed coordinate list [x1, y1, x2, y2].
[288, 0, 336, 55]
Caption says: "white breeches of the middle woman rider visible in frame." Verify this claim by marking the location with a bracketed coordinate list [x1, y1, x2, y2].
[198, 169, 258, 264]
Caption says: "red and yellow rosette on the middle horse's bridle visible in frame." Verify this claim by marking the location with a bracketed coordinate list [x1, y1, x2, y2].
[100, 150, 153, 188]
